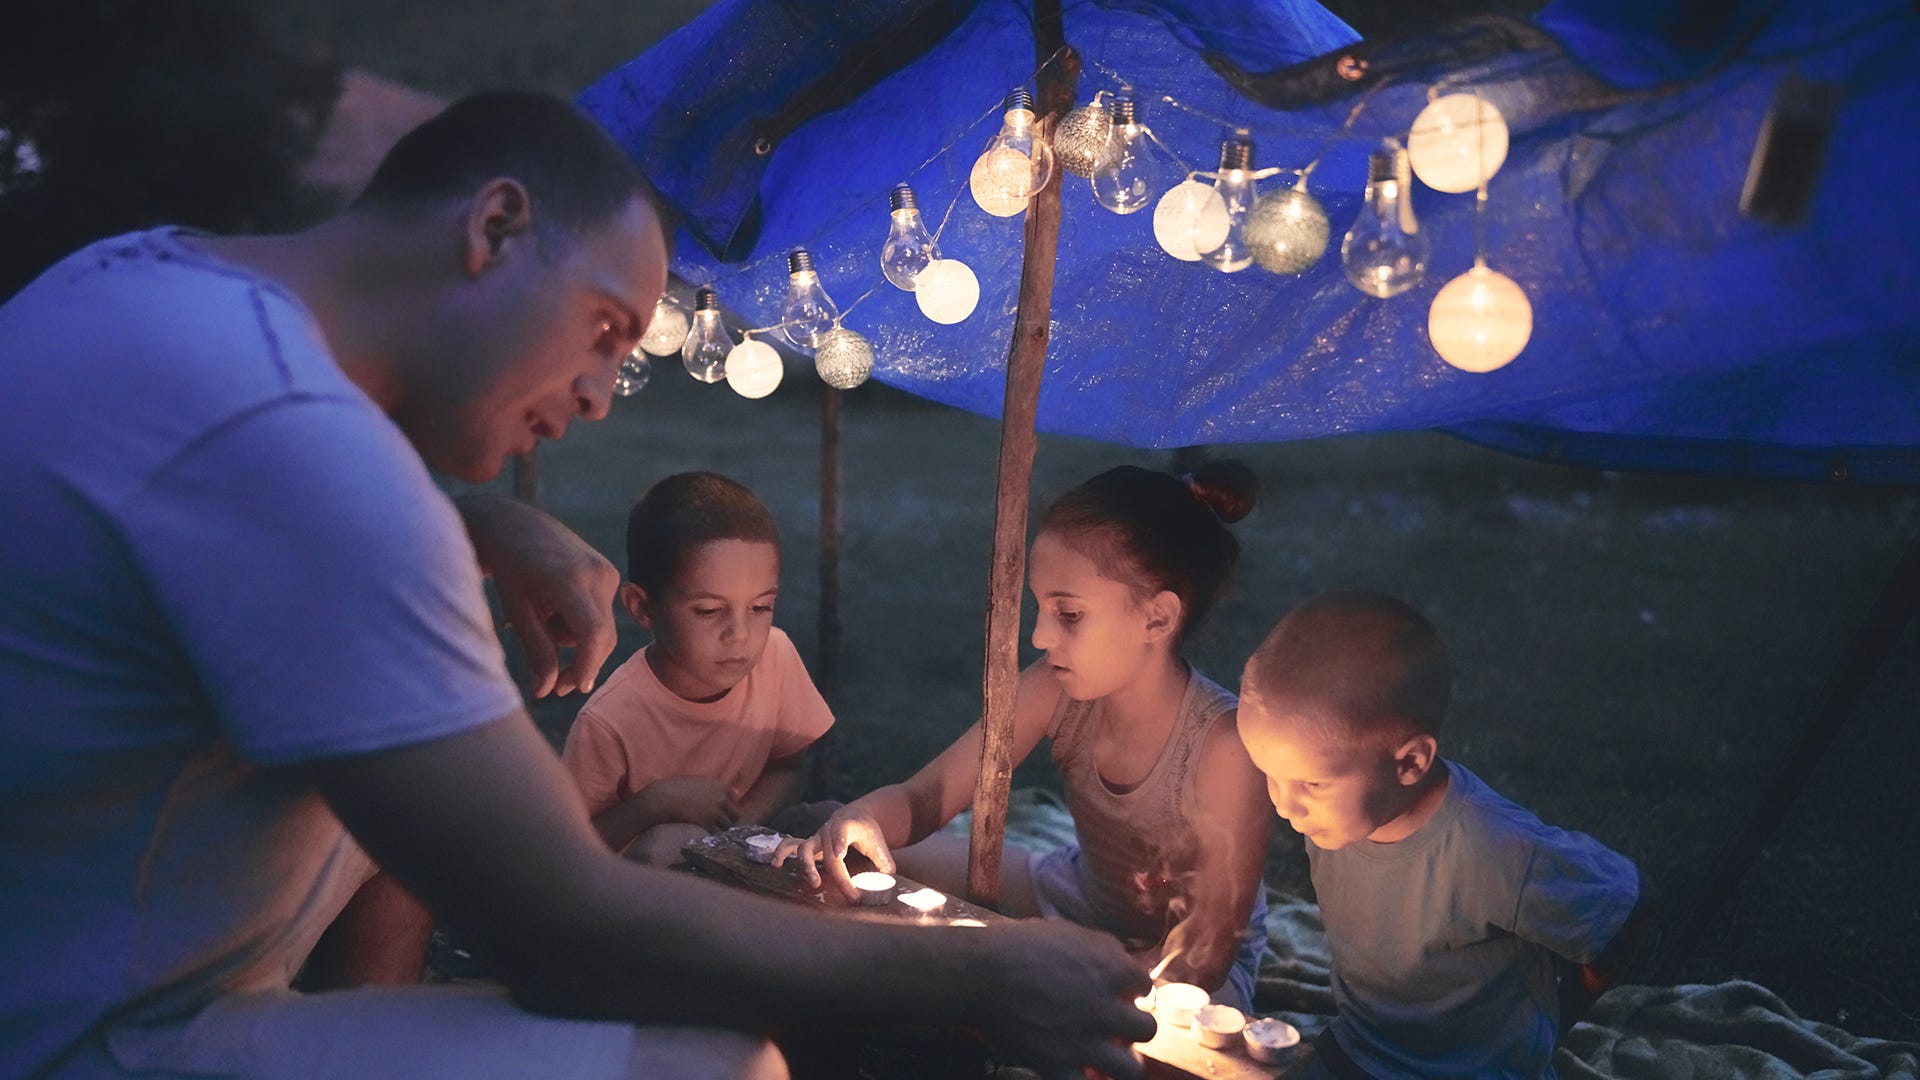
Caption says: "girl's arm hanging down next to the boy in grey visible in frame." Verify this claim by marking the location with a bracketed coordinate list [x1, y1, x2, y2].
[1162, 711, 1273, 990]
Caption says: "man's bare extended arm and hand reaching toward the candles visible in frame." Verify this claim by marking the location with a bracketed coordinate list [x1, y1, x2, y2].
[291, 711, 1152, 1078]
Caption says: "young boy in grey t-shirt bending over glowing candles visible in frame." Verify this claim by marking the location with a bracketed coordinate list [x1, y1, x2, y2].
[1240, 592, 1640, 1080]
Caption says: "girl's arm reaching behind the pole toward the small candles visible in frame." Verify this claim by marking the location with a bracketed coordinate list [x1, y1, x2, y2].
[774, 665, 1067, 899]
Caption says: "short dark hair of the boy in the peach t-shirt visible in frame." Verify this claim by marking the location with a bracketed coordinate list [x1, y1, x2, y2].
[626, 473, 780, 596]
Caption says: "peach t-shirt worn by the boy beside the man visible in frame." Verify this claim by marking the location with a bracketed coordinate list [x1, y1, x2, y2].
[561, 626, 833, 817]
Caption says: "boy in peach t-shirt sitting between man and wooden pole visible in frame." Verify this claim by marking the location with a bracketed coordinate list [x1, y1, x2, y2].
[561, 473, 833, 865]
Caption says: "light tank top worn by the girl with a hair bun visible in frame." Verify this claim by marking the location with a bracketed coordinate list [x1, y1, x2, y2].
[1046, 671, 1238, 947]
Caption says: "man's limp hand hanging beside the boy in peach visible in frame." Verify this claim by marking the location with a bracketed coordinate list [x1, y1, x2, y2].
[457, 496, 620, 698]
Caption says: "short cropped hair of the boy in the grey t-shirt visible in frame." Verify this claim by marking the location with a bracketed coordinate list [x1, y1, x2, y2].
[1240, 590, 1452, 748]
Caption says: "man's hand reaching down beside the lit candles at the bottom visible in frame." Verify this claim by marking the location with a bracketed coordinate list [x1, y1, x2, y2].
[977, 919, 1154, 1080]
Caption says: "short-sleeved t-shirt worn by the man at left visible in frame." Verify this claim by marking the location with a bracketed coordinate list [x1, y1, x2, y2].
[0, 229, 520, 1076]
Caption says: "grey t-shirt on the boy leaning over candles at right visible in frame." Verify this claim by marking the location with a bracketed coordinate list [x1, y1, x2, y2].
[1306, 761, 1640, 1080]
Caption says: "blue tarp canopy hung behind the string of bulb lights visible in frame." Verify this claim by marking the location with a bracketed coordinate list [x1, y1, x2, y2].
[580, 0, 1920, 482]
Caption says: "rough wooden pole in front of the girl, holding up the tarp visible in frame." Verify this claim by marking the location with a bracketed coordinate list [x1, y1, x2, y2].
[966, 10, 1079, 907]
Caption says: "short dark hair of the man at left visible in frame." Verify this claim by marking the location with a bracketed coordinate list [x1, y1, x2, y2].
[353, 90, 672, 256]
